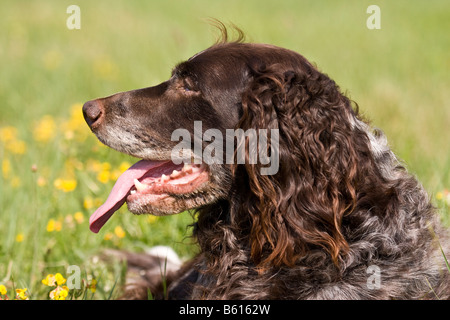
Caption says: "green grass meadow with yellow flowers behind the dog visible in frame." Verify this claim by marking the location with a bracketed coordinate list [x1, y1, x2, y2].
[0, 0, 450, 299]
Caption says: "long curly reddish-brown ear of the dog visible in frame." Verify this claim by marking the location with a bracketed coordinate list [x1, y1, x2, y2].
[234, 60, 365, 270]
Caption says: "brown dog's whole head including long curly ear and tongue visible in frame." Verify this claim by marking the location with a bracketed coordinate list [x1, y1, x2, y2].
[83, 30, 375, 265]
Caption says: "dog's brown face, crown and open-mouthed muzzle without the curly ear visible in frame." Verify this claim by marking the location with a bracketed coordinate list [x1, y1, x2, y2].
[83, 42, 313, 231]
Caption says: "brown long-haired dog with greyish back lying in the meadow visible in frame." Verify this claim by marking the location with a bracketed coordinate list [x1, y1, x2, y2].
[83, 27, 450, 299]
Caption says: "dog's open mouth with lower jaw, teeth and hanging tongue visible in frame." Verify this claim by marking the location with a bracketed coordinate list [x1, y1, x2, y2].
[89, 160, 209, 233]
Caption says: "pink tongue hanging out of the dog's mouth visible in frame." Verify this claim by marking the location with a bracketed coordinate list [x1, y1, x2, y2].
[89, 160, 167, 233]
